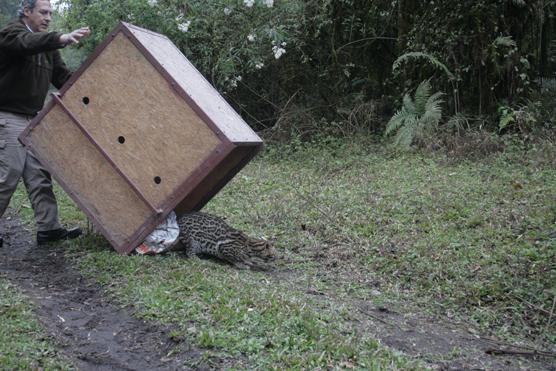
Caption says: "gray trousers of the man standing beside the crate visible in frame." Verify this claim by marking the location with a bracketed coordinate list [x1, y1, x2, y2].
[0, 111, 61, 231]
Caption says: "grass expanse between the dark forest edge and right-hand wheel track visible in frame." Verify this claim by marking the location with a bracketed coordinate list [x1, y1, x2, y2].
[205, 141, 556, 342]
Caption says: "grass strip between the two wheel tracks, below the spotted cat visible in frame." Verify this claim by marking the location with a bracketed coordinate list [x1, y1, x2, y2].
[69, 241, 418, 369]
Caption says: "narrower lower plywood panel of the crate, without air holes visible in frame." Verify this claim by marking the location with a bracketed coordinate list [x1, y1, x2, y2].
[28, 106, 151, 245]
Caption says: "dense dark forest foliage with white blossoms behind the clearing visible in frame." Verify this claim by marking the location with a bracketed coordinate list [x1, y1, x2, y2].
[0, 0, 556, 140]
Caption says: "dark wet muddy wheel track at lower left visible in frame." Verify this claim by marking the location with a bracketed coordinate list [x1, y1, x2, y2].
[0, 212, 218, 370]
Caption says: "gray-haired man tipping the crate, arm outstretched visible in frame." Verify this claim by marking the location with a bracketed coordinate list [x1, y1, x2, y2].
[0, 0, 90, 246]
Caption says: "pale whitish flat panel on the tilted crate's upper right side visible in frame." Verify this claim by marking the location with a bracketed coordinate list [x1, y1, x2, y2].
[127, 25, 262, 142]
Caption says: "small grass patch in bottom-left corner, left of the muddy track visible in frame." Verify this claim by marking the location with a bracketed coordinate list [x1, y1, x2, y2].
[0, 277, 72, 370]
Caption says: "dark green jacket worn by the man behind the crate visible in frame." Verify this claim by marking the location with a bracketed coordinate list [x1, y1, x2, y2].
[0, 21, 71, 116]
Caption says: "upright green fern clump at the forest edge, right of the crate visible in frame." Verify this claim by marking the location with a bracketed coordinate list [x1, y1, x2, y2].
[384, 80, 443, 149]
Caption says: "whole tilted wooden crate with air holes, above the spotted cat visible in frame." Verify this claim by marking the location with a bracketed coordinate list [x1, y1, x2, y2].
[20, 23, 262, 253]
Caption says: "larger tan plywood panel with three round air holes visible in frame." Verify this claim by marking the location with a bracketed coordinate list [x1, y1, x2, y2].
[59, 33, 220, 206]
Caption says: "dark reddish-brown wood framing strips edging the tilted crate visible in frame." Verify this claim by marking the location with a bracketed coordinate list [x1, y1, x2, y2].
[19, 22, 262, 254]
